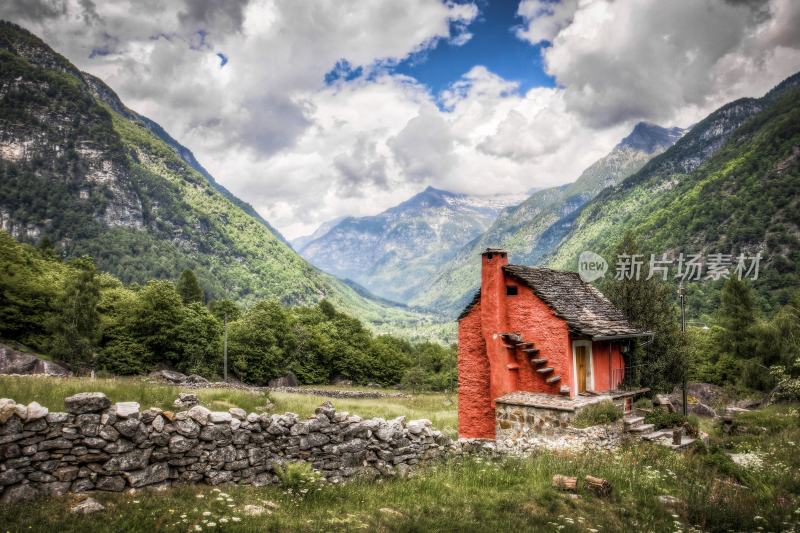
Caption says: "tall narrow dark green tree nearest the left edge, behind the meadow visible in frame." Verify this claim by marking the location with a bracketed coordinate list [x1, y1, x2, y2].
[51, 257, 100, 367]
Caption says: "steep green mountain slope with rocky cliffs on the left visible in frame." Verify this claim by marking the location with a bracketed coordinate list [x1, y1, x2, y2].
[0, 22, 428, 325]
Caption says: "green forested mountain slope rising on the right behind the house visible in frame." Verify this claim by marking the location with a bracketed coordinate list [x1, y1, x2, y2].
[547, 74, 800, 312]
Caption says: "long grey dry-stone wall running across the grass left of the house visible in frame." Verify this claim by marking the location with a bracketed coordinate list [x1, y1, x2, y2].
[0, 393, 450, 502]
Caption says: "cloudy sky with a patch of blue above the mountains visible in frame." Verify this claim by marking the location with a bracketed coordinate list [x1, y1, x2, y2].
[0, 0, 800, 237]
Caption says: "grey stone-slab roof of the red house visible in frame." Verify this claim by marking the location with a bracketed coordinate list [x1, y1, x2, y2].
[503, 265, 646, 337]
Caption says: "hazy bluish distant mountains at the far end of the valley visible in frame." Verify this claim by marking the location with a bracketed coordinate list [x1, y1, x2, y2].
[300, 122, 683, 308]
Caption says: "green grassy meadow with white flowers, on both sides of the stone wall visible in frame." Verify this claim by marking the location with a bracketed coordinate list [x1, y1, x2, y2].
[0, 378, 800, 533]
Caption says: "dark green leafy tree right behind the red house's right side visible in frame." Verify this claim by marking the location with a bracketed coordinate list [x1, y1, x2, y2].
[604, 233, 687, 390]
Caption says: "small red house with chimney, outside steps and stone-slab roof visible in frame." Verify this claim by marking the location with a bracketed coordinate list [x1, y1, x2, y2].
[458, 248, 649, 438]
